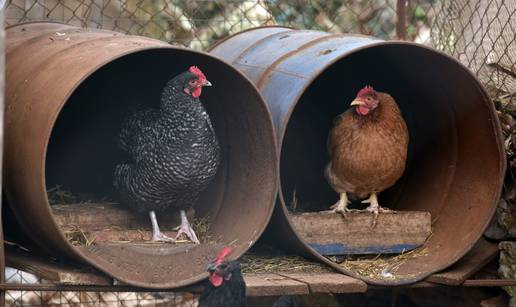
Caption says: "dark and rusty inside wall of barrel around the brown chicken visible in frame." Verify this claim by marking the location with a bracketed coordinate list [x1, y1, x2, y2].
[280, 44, 504, 282]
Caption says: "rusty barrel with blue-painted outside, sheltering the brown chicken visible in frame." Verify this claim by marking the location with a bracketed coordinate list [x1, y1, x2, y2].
[211, 27, 505, 284]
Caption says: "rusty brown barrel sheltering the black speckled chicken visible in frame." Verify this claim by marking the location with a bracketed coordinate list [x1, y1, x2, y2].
[4, 23, 277, 288]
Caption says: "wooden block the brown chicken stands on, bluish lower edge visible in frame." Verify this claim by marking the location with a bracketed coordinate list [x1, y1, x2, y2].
[290, 211, 432, 255]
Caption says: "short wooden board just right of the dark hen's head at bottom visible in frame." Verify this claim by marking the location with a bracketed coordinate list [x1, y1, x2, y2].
[244, 274, 309, 296]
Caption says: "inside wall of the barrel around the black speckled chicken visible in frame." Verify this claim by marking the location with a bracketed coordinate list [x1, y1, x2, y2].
[46, 49, 275, 288]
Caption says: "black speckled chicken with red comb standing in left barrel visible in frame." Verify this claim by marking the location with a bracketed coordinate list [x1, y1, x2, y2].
[114, 66, 220, 243]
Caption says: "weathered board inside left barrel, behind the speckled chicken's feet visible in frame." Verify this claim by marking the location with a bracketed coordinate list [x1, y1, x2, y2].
[51, 203, 194, 230]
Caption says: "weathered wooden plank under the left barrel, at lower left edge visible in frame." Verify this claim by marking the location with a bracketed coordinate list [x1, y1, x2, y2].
[6, 248, 113, 286]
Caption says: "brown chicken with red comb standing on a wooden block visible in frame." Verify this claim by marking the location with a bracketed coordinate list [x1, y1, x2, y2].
[325, 86, 409, 216]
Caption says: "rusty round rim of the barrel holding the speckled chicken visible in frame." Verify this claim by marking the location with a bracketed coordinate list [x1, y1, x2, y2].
[6, 22, 279, 289]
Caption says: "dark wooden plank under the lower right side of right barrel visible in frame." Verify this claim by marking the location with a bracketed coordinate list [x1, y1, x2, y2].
[426, 238, 498, 286]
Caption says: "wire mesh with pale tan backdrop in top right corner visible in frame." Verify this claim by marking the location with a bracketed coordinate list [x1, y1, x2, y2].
[428, 0, 516, 107]
